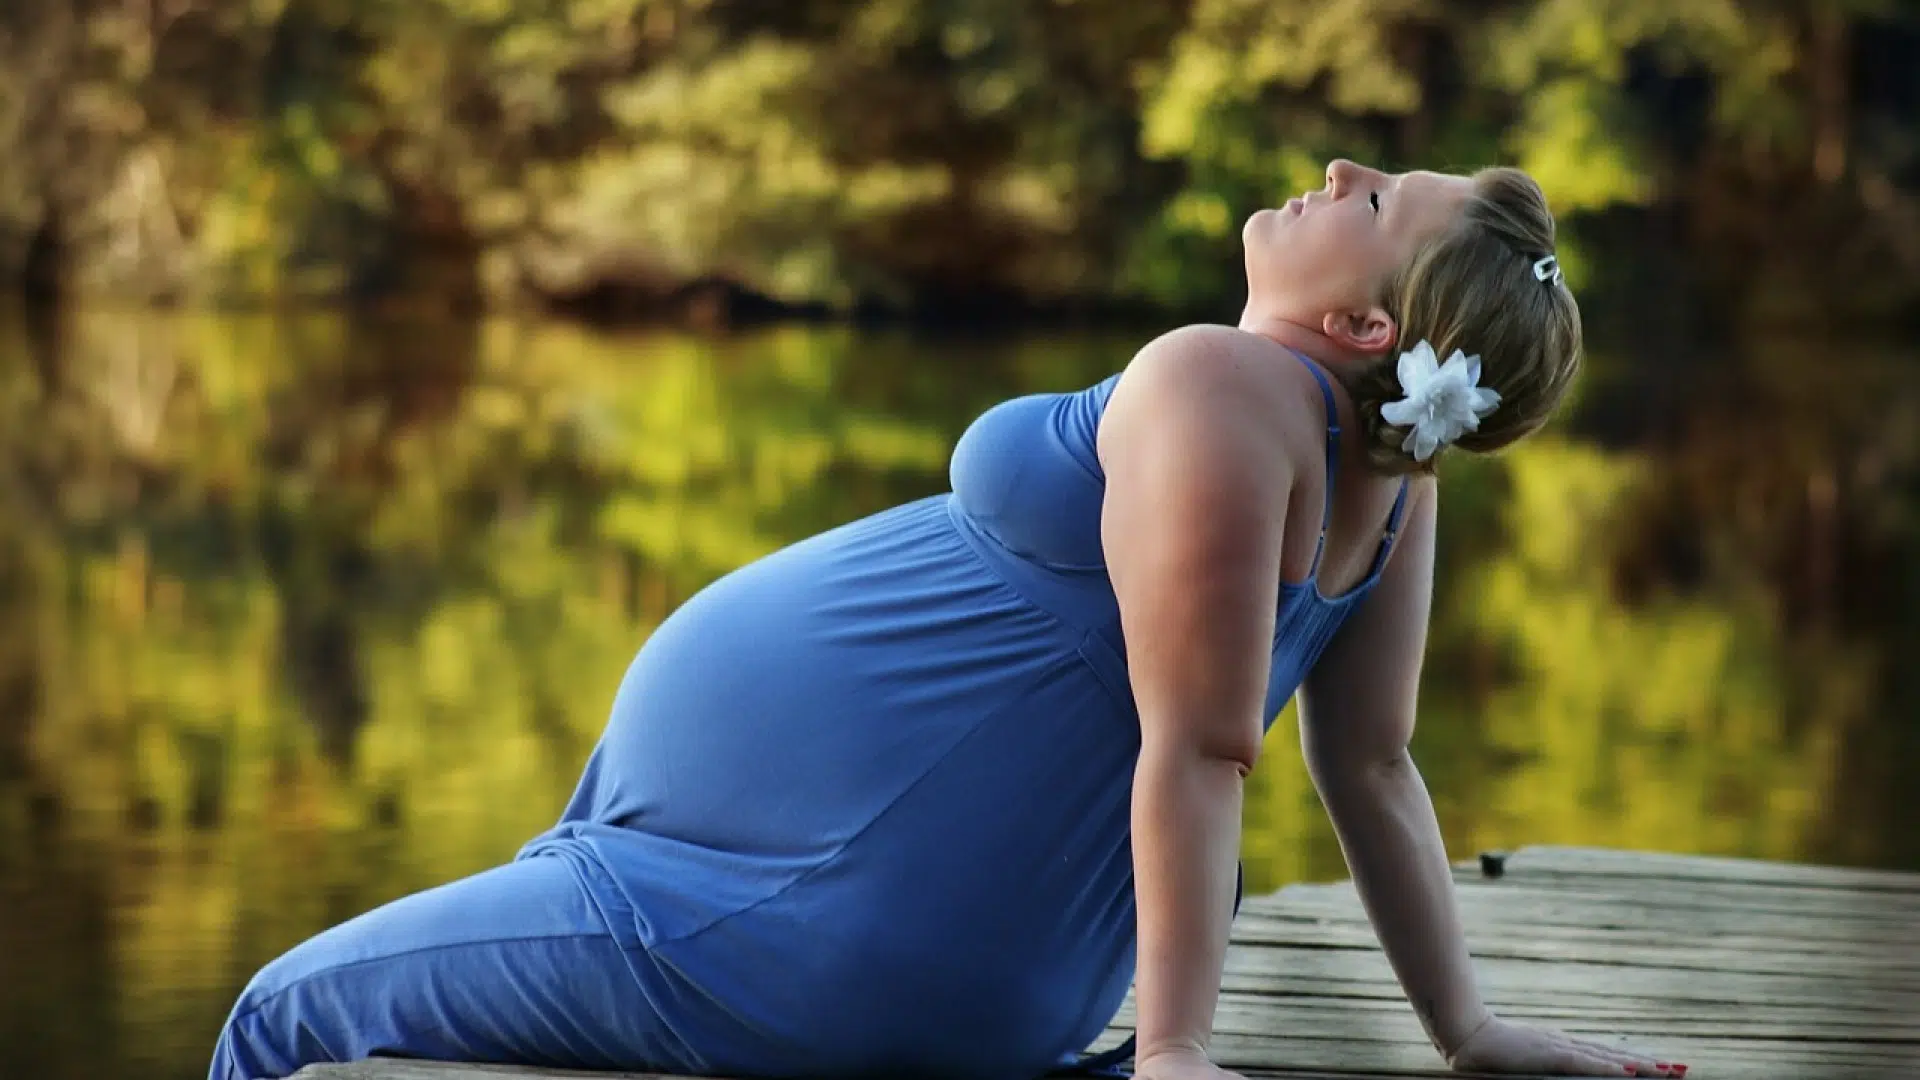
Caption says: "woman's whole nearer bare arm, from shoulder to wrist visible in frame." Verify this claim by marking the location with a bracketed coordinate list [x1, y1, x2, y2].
[1100, 327, 1319, 1063]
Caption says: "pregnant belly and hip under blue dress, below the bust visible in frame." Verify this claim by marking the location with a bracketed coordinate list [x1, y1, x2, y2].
[541, 502, 1139, 1078]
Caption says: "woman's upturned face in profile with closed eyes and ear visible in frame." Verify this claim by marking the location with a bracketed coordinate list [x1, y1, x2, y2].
[1240, 160, 1473, 352]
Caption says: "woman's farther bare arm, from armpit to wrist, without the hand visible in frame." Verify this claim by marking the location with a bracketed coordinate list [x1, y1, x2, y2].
[1300, 479, 1488, 1059]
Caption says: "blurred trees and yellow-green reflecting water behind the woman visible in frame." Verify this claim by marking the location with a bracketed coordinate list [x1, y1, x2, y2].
[0, 0, 1920, 1080]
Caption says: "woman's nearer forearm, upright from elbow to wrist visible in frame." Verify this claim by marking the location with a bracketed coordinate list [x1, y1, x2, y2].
[1133, 740, 1244, 1059]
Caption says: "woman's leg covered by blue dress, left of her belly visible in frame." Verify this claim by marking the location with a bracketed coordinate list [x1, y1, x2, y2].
[209, 857, 676, 1080]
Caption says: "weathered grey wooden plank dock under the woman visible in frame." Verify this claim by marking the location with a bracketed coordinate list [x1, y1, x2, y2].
[300, 847, 1920, 1080]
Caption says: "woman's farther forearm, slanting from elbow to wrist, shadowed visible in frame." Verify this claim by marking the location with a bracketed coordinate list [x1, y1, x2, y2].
[1309, 753, 1488, 1057]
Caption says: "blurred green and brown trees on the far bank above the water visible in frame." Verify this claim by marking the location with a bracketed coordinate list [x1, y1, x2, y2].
[0, 0, 1920, 307]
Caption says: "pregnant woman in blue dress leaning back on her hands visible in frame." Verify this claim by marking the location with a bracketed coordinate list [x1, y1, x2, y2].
[211, 161, 1680, 1080]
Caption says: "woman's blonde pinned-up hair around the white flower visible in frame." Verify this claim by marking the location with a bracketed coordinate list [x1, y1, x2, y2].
[1344, 169, 1582, 475]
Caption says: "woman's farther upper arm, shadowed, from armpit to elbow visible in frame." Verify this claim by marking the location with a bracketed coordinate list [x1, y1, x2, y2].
[1300, 479, 1440, 765]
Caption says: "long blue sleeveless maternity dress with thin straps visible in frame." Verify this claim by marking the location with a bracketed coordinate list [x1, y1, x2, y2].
[211, 349, 1405, 1080]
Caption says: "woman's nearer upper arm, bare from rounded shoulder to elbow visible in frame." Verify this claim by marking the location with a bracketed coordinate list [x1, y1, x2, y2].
[1100, 327, 1300, 769]
